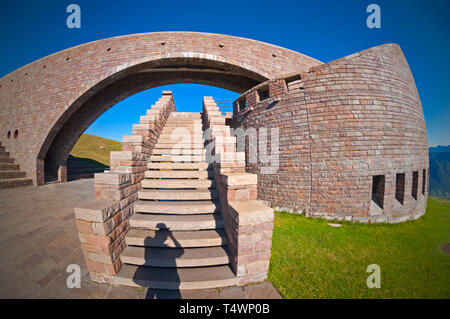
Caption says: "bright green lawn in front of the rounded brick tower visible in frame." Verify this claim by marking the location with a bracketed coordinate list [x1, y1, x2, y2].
[269, 198, 450, 298]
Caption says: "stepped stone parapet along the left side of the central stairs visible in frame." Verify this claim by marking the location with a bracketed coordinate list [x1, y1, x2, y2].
[75, 91, 175, 283]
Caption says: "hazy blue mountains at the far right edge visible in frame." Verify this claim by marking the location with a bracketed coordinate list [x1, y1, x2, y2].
[429, 145, 450, 199]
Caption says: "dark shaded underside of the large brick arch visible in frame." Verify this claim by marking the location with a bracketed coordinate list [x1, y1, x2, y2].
[38, 58, 253, 182]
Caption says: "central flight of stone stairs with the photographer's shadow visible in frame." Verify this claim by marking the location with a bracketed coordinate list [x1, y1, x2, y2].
[114, 112, 238, 290]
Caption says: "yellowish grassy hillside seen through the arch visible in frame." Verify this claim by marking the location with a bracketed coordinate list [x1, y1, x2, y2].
[70, 134, 122, 166]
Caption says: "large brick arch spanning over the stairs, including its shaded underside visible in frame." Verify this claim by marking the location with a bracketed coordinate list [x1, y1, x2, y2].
[0, 32, 321, 184]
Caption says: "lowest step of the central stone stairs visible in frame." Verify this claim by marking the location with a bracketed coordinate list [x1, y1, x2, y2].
[113, 265, 240, 290]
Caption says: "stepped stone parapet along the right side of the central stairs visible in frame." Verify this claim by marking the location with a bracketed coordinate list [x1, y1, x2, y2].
[203, 97, 274, 285]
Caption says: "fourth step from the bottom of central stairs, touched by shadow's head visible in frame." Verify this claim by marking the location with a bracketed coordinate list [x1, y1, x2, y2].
[129, 214, 224, 231]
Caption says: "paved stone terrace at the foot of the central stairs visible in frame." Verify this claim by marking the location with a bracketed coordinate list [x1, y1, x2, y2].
[0, 179, 280, 299]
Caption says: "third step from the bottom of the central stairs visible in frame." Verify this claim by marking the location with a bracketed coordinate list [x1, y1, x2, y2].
[125, 228, 227, 248]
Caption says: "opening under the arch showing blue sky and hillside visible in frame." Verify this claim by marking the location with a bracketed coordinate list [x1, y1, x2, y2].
[66, 84, 239, 182]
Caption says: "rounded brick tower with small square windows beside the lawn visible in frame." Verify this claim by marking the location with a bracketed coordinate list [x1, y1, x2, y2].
[234, 44, 428, 222]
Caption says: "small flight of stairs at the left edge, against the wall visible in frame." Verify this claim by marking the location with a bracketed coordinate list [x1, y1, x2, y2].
[0, 142, 33, 188]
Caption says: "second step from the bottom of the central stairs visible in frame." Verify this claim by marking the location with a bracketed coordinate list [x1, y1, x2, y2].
[120, 246, 230, 268]
